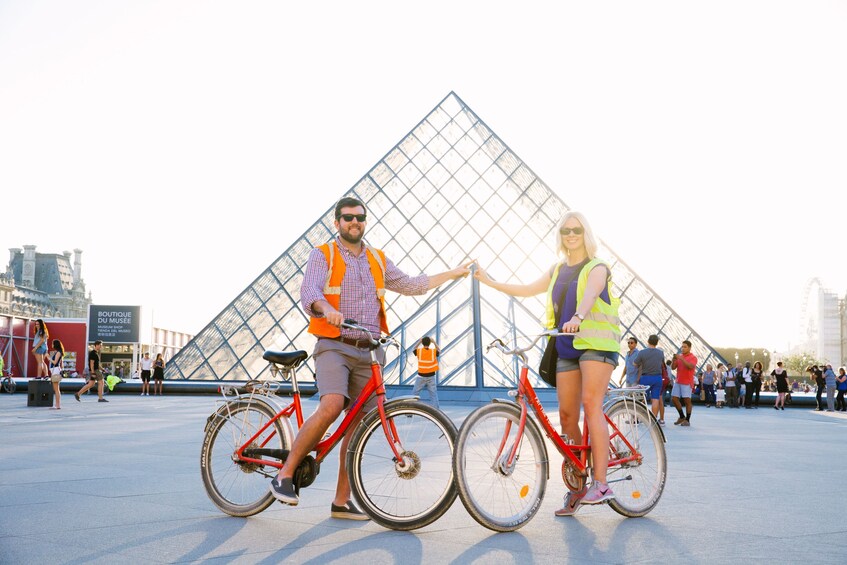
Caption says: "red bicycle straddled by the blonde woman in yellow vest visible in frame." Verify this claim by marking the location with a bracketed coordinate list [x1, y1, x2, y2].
[453, 331, 667, 532]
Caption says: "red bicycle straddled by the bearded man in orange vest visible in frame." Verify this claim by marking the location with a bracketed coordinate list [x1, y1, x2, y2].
[200, 320, 457, 530]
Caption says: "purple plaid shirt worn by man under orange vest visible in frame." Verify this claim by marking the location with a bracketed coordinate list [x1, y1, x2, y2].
[300, 238, 429, 339]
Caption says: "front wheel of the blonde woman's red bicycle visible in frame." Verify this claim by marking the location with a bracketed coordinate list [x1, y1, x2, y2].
[453, 403, 549, 532]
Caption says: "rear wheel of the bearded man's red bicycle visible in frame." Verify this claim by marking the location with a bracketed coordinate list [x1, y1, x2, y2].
[200, 401, 290, 517]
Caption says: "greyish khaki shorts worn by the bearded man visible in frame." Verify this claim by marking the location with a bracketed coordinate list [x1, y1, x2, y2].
[313, 339, 385, 410]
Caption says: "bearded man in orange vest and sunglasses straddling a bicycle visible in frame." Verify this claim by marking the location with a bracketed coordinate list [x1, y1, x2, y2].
[270, 197, 472, 520]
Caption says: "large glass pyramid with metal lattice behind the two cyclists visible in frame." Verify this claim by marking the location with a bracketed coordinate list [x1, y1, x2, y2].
[166, 92, 723, 398]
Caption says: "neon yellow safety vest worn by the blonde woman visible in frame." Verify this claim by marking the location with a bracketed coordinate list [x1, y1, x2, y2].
[544, 259, 621, 352]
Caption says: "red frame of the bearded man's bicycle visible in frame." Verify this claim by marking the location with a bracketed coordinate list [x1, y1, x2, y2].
[229, 351, 403, 469]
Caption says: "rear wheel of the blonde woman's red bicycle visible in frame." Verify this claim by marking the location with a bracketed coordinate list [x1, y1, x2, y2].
[606, 402, 667, 518]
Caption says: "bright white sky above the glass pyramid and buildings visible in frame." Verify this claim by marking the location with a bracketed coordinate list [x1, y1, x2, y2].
[0, 0, 847, 350]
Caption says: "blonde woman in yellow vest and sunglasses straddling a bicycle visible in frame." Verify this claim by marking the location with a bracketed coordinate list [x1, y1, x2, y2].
[474, 211, 621, 516]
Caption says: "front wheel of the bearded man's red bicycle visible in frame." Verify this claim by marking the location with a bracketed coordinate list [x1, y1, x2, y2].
[346, 400, 457, 530]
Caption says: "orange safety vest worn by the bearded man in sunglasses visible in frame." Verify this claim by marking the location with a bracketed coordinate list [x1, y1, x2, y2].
[309, 241, 389, 337]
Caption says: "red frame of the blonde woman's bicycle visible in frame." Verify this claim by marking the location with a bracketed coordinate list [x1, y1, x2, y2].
[498, 364, 641, 476]
